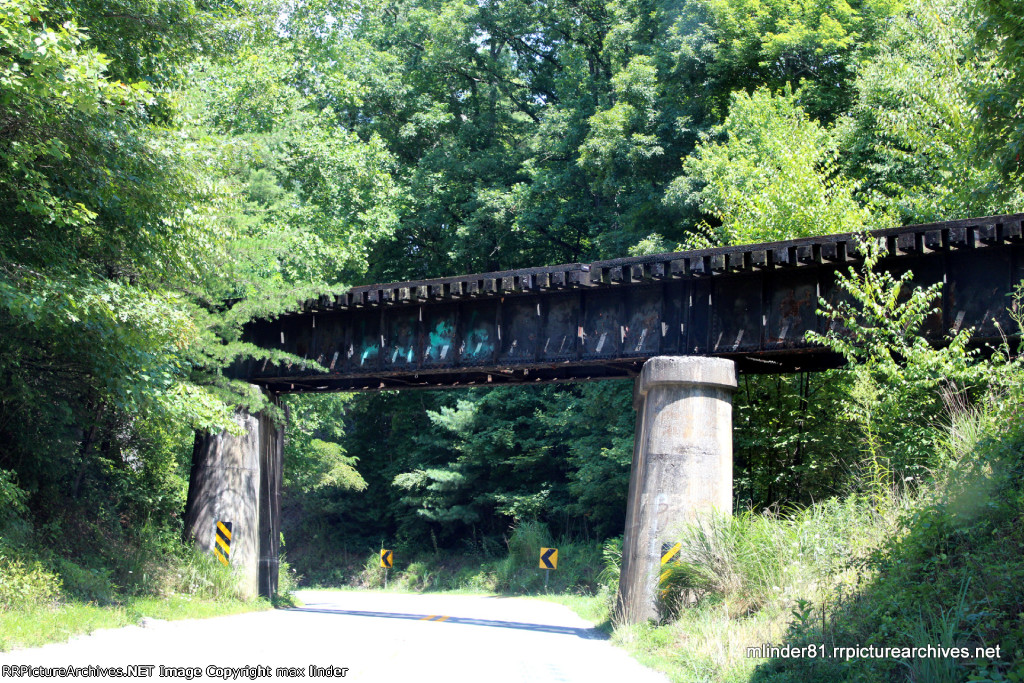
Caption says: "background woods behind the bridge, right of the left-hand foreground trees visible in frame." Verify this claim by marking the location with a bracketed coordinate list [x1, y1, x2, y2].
[284, 0, 1021, 575]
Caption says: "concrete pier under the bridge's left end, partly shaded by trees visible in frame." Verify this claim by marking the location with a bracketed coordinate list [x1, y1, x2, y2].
[184, 393, 285, 598]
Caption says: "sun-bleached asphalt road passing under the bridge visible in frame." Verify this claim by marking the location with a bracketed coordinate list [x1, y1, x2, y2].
[0, 591, 667, 683]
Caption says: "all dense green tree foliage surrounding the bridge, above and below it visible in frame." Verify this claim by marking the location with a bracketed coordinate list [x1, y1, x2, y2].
[0, 0, 1024, 679]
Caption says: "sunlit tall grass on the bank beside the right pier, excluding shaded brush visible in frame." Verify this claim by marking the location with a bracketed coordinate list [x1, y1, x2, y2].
[613, 497, 904, 682]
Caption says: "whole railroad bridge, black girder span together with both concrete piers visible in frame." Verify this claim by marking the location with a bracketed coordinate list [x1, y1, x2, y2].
[186, 214, 1024, 621]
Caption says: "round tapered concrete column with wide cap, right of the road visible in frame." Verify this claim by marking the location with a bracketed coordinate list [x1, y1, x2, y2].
[616, 356, 736, 624]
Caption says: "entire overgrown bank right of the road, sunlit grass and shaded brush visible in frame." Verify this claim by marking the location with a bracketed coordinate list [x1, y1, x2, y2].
[613, 376, 1024, 683]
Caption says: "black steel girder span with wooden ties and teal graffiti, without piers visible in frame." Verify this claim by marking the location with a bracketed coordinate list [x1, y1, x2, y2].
[232, 214, 1024, 392]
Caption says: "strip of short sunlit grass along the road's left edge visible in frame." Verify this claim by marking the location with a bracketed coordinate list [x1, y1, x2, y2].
[0, 595, 271, 651]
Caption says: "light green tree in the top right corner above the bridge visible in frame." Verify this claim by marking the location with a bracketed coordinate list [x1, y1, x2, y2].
[840, 0, 1022, 224]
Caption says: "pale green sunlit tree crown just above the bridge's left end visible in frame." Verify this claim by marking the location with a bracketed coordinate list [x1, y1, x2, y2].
[185, 38, 397, 286]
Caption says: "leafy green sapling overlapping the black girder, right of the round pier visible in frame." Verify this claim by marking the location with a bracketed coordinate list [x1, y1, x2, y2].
[807, 240, 981, 500]
